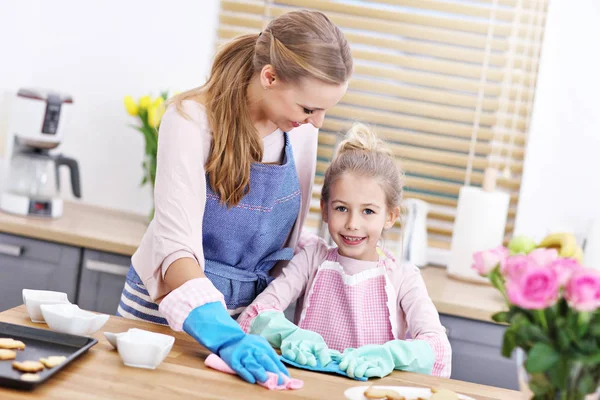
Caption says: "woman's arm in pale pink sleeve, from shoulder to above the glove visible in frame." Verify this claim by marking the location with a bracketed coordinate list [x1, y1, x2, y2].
[152, 101, 211, 290]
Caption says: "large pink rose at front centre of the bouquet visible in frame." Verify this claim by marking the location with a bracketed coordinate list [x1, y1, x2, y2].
[506, 266, 560, 310]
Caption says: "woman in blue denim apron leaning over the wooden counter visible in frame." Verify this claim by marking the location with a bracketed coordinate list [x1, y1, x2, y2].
[117, 11, 352, 383]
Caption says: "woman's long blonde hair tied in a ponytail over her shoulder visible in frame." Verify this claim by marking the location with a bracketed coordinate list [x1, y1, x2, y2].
[168, 10, 352, 207]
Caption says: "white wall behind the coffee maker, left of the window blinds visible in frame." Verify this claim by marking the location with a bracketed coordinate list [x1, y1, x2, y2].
[0, 0, 219, 214]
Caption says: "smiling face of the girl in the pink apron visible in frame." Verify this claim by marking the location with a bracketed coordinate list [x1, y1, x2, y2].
[321, 173, 399, 261]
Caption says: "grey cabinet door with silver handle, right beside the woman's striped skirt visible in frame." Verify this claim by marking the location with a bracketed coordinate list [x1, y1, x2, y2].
[78, 249, 131, 315]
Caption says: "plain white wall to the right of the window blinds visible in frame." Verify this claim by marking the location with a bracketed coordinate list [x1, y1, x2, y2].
[515, 0, 600, 242]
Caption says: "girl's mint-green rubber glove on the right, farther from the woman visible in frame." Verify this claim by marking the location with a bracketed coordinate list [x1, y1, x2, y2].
[339, 340, 435, 378]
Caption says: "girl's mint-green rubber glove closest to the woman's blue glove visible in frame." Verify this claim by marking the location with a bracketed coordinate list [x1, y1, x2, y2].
[250, 311, 331, 367]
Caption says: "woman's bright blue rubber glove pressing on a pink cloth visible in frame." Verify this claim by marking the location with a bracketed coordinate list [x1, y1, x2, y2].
[183, 302, 289, 384]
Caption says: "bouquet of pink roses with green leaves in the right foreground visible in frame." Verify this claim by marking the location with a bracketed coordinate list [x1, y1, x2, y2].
[473, 234, 600, 400]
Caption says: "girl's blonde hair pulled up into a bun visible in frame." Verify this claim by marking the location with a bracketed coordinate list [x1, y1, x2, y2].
[321, 124, 403, 210]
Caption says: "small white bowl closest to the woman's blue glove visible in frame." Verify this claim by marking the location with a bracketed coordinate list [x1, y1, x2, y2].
[115, 328, 175, 369]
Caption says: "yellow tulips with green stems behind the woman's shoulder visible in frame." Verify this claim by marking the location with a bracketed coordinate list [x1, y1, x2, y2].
[124, 92, 168, 219]
